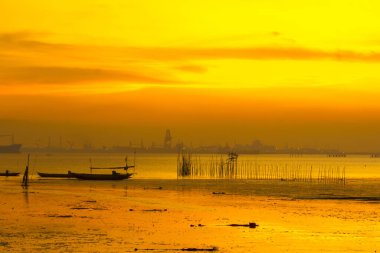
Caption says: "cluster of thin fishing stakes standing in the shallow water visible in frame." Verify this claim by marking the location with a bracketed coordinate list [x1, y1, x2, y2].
[177, 151, 346, 183]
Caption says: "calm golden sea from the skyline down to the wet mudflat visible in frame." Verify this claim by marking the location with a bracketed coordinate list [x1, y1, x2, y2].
[0, 153, 380, 202]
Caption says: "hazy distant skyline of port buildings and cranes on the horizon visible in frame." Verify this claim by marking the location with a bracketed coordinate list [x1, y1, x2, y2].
[0, 129, 352, 154]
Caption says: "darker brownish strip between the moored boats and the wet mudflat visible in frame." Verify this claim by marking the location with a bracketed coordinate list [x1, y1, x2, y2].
[0, 175, 380, 202]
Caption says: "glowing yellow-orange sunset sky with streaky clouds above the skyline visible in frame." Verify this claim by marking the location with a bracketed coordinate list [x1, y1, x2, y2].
[0, 0, 380, 151]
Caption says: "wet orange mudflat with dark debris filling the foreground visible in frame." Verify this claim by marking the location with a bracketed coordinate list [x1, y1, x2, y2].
[0, 180, 380, 252]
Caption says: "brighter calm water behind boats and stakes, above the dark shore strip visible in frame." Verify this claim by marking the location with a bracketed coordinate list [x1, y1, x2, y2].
[0, 153, 380, 179]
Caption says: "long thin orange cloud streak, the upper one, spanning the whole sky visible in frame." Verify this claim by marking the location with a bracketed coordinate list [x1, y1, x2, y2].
[0, 32, 380, 62]
